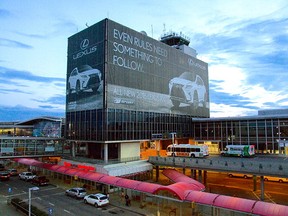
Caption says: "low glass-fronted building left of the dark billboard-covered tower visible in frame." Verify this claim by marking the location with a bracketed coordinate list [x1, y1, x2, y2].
[0, 117, 65, 157]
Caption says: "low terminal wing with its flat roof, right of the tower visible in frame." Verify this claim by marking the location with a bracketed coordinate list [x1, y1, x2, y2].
[192, 109, 288, 155]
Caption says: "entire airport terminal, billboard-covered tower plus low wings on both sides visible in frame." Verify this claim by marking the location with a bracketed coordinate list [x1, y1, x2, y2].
[0, 19, 288, 162]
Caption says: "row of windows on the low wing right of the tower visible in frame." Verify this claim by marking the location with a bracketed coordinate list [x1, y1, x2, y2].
[193, 119, 288, 153]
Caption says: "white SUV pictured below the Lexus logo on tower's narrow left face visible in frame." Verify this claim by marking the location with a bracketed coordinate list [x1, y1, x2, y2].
[67, 65, 101, 94]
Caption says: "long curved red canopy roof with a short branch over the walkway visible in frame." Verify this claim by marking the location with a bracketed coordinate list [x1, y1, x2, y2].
[14, 158, 288, 216]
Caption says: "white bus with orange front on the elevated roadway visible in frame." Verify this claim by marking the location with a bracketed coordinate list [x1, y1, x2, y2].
[166, 144, 209, 158]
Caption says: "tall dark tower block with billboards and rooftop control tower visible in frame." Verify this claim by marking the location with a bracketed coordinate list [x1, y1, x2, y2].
[66, 19, 210, 161]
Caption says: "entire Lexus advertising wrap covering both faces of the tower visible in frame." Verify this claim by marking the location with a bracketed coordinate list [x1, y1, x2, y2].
[66, 19, 209, 117]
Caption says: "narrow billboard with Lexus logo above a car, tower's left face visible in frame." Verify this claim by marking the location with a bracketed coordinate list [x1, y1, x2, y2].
[66, 21, 105, 112]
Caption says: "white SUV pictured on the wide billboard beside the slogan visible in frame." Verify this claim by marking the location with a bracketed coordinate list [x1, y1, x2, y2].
[169, 72, 208, 109]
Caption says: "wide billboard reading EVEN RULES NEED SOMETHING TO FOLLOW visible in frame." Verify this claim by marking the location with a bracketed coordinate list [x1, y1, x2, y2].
[106, 20, 209, 117]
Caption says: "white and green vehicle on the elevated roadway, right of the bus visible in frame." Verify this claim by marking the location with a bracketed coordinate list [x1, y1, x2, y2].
[220, 145, 255, 157]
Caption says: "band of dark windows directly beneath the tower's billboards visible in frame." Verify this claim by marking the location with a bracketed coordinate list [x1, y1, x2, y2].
[66, 109, 192, 141]
